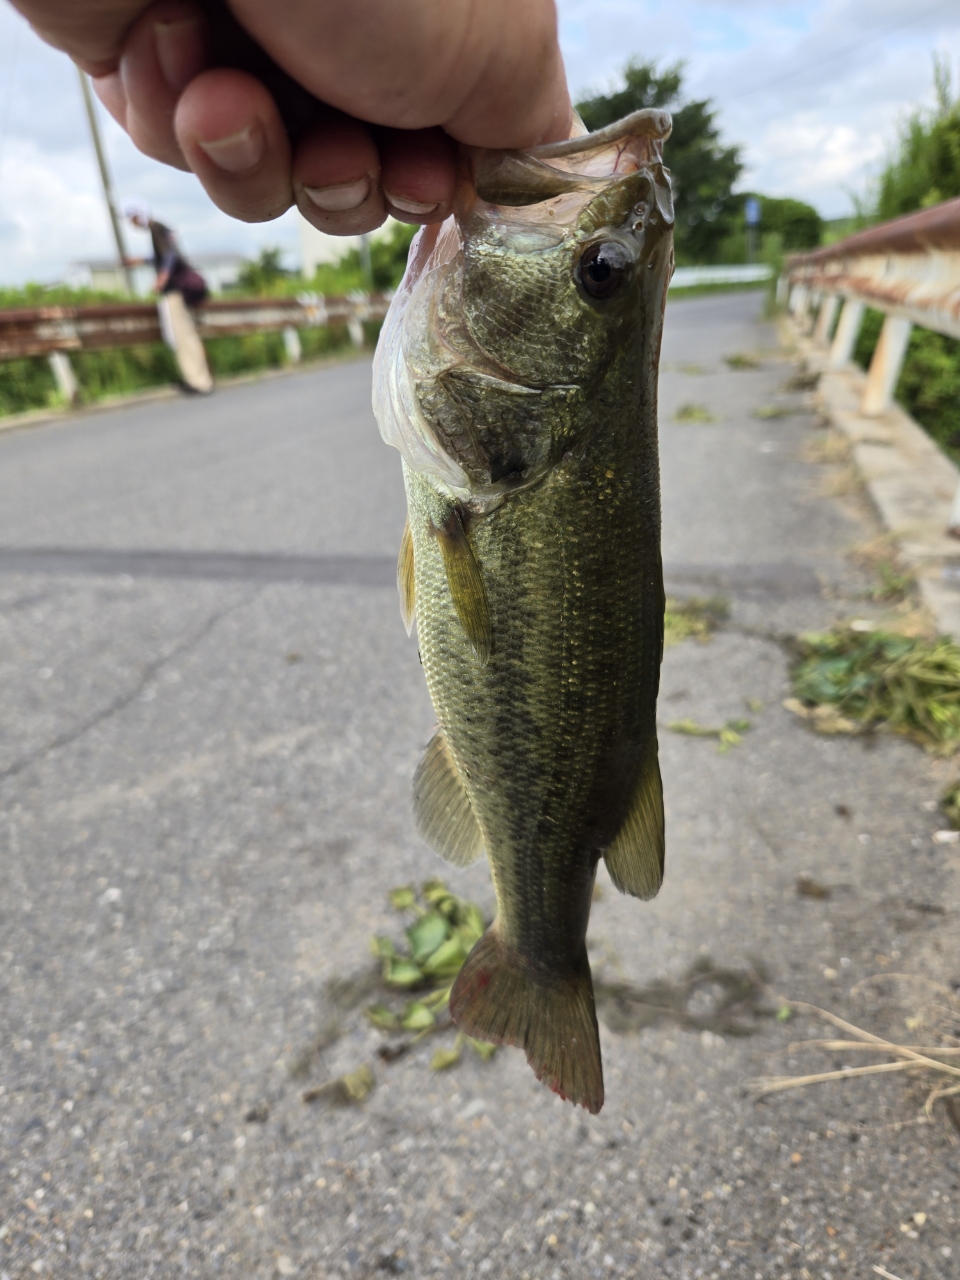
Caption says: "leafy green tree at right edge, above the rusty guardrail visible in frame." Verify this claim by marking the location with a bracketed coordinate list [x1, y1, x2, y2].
[876, 58, 960, 221]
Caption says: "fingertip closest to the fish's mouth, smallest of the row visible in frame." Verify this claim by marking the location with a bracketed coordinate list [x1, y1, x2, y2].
[376, 129, 457, 224]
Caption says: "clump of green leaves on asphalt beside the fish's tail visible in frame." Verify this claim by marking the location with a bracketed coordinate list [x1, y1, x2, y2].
[366, 879, 497, 1071]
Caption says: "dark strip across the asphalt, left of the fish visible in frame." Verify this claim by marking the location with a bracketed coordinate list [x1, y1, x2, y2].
[0, 547, 397, 586]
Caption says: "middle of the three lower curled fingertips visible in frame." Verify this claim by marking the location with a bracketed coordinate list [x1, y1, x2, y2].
[293, 111, 387, 236]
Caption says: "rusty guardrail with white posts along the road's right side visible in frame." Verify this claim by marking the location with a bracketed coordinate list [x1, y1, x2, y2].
[782, 200, 960, 416]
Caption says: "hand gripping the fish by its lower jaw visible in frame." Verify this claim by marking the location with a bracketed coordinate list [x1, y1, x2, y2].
[13, 0, 571, 236]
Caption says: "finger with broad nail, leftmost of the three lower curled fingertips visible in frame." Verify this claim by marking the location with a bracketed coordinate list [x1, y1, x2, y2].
[174, 68, 293, 223]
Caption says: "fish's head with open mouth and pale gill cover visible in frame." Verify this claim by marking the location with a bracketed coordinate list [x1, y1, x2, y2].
[374, 110, 673, 513]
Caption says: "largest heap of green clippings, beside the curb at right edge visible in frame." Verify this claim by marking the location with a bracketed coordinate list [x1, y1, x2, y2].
[783, 623, 960, 755]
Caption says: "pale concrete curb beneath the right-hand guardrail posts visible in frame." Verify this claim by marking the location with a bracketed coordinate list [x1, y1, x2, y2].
[788, 321, 960, 640]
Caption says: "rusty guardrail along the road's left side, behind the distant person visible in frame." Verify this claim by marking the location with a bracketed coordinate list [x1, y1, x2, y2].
[0, 293, 389, 402]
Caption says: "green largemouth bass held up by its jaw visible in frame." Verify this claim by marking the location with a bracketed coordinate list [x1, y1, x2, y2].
[374, 109, 673, 1114]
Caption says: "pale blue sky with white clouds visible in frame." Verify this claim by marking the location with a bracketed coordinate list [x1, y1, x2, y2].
[0, 0, 960, 284]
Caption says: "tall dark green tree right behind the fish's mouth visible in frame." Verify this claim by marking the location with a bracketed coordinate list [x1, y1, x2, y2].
[577, 61, 744, 262]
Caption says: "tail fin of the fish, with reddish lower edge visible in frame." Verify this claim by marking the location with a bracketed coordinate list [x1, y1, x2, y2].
[451, 927, 603, 1115]
